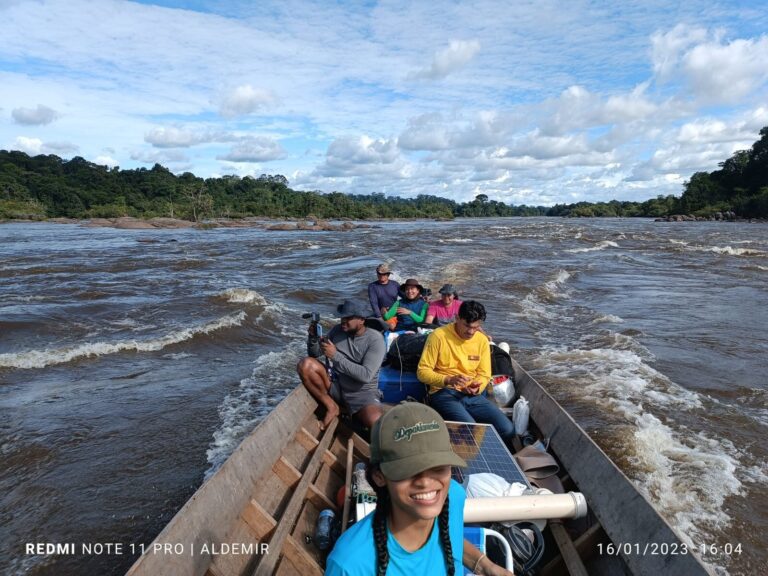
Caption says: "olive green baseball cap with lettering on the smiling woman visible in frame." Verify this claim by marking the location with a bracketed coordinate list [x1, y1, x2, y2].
[371, 402, 467, 482]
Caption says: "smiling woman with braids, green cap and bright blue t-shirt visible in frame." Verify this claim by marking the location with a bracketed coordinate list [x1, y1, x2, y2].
[325, 402, 512, 576]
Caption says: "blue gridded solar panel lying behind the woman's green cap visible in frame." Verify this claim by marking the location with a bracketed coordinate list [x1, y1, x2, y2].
[446, 422, 531, 488]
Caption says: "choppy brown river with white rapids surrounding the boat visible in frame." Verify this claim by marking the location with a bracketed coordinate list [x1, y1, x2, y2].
[0, 218, 768, 575]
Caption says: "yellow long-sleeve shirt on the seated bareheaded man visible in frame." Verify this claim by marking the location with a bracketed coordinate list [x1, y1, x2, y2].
[416, 324, 491, 394]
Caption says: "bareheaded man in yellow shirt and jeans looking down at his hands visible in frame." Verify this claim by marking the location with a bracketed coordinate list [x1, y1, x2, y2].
[416, 300, 515, 445]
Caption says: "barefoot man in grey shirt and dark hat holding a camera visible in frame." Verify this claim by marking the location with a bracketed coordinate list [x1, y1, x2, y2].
[297, 300, 386, 429]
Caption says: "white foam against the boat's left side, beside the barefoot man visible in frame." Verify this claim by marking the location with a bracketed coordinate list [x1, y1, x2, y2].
[205, 339, 306, 480]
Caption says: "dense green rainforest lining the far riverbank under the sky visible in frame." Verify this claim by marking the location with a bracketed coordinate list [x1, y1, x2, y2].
[0, 127, 768, 221]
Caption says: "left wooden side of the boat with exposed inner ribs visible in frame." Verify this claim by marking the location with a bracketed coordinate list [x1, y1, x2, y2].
[128, 387, 343, 576]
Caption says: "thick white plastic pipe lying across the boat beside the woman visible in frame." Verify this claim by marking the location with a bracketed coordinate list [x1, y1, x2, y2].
[464, 492, 587, 522]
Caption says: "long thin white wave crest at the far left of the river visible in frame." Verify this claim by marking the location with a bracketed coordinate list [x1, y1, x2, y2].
[0, 312, 246, 369]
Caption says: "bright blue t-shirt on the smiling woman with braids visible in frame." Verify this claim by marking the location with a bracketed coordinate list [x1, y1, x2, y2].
[325, 480, 466, 576]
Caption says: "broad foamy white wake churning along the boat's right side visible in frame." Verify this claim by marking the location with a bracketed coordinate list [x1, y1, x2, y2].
[515, 269, 768, 574]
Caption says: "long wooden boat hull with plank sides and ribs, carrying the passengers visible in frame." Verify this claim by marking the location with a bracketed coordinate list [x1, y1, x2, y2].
[128, 365, 711, 576]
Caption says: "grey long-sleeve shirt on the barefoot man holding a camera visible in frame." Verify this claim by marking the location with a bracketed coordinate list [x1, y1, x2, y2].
[307, 325, 386, 392]
